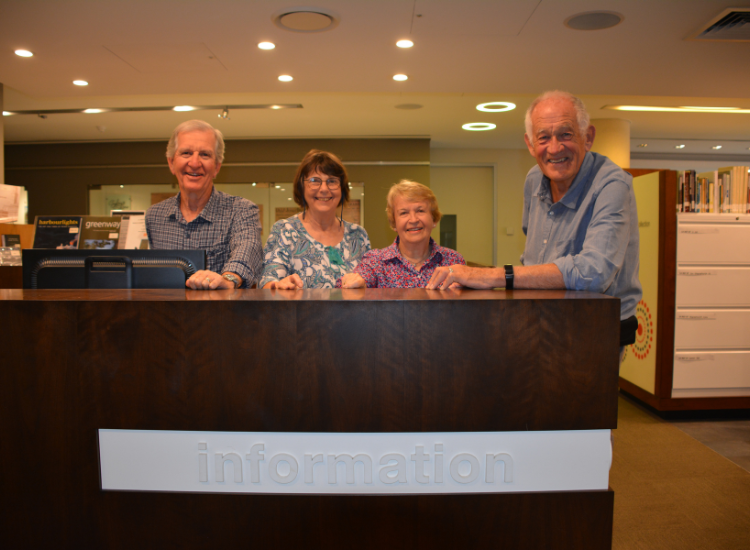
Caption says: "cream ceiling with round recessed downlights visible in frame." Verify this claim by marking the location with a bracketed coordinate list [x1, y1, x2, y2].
[0, 0, 750, 158]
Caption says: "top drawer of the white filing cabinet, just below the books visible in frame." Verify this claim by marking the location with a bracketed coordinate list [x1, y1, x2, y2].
[677, 222, 750, 264]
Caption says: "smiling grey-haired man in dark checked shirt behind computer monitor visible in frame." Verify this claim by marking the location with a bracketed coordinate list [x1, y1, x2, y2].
[146, 120, 263, 290]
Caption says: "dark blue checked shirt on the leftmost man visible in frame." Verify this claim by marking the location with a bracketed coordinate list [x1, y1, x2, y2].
[146, 189, 263, 288]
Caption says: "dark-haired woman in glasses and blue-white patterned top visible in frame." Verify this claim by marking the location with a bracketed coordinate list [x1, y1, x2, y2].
[258, 149, 370, 290]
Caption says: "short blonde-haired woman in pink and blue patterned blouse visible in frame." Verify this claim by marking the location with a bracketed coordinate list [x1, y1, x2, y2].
[336, 180, 466, 294]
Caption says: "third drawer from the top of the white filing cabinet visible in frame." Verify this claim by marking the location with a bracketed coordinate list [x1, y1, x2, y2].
[674, 309, 750, 351]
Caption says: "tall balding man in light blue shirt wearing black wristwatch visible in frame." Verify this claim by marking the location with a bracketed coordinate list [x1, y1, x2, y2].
[427, 91, 642, 335]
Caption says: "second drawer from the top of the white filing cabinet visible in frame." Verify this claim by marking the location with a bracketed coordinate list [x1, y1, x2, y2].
[676, 266, 750, 307]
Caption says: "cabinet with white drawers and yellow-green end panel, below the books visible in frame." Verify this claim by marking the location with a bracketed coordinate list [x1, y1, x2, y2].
[620, 170, 750, 411]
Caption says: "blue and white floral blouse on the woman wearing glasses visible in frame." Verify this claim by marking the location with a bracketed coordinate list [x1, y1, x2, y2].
[258, 215, 370, 288]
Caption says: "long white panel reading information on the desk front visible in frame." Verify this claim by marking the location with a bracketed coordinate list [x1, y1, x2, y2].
[99, 430, 612, 494]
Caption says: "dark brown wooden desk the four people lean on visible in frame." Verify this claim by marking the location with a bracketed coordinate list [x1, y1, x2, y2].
[0, 289, 620, 549]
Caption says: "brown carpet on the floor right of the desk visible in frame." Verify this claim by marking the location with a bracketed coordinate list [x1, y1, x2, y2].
[610, 397, 750, 550]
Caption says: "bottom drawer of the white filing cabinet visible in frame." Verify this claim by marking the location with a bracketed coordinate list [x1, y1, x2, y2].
[672, 351, 750, 389]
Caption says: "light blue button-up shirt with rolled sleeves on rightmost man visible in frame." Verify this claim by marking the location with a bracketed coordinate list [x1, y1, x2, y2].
[521, 152, 643, 319]
